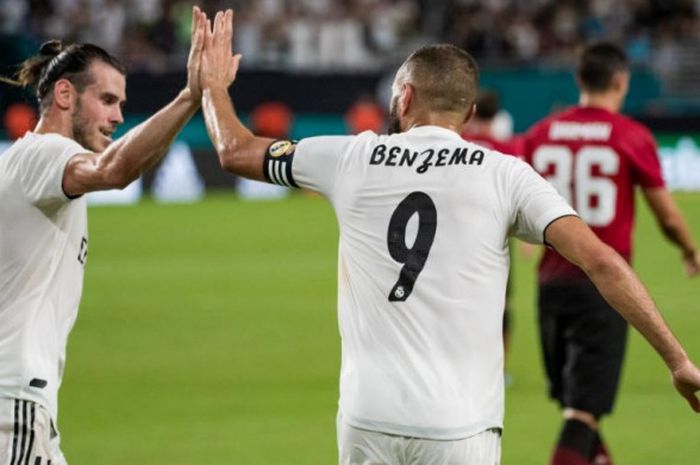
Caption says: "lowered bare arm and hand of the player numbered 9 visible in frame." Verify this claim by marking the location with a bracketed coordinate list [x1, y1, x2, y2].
[545, 216, 700, 412]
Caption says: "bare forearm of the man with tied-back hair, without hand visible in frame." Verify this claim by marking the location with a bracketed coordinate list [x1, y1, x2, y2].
[97, 90, 200, 187]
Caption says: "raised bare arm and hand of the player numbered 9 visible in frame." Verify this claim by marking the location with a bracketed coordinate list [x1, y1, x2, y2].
[201, 10, 273, 181]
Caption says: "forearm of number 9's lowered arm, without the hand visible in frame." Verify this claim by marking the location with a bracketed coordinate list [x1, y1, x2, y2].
[585, 254, 688, 371]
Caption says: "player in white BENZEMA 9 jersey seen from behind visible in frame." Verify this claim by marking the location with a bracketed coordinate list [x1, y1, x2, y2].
[200, 11, 700, 465]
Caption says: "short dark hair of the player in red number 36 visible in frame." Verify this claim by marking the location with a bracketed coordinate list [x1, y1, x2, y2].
[576, 42, 629, 92]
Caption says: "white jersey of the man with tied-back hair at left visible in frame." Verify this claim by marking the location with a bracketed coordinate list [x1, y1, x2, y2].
[0, 133, 87, 420]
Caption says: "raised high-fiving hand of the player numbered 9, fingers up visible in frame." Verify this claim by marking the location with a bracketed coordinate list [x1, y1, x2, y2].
[200, 10, 241, 89]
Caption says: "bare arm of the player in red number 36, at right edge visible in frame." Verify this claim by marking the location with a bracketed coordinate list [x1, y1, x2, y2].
[642, 187, 700, 276]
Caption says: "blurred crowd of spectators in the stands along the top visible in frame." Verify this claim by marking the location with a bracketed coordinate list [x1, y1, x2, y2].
[0, 0, 700, 72]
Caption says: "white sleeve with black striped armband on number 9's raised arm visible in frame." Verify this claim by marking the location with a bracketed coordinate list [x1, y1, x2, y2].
[263, 136, 355, 196]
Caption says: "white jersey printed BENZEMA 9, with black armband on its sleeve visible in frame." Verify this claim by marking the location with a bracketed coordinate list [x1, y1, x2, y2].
[264, 126, 575, 439]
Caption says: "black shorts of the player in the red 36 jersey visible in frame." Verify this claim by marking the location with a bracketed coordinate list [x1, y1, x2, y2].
[539, 281, 627, 417]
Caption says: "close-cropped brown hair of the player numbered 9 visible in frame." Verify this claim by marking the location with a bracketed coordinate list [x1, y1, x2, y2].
[402, 44, 479, 113]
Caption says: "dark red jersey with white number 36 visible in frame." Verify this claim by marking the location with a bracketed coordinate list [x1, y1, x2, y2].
[522, 107, 664, 283]
